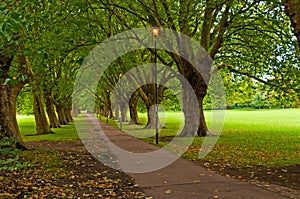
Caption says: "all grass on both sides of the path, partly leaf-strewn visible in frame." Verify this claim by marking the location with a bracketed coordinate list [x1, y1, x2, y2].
[16, 109, 300, 193]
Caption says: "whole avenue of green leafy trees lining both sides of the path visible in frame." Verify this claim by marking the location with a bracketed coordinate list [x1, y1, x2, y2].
[0, 0, 300, 148]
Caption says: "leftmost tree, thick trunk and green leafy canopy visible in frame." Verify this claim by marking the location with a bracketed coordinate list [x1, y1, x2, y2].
[0, 0, 92, 147]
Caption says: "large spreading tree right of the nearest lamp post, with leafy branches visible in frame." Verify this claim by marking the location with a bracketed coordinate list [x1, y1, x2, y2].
[94, 0, 293, 136]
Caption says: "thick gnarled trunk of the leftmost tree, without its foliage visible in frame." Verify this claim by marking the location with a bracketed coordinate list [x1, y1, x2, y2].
[0, 83, 25, 149]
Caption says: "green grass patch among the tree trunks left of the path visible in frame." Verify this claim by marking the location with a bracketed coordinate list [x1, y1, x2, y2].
[18, 116, 79, 142]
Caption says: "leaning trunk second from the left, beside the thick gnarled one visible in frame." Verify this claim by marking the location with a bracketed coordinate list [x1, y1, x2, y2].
[33, 89, 53, 135]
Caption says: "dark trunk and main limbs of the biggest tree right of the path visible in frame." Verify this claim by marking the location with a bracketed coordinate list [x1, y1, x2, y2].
[175, 1, 230, 136]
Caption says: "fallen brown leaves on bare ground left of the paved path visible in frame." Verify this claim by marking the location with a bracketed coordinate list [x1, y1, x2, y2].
[0, 141, 149, 199]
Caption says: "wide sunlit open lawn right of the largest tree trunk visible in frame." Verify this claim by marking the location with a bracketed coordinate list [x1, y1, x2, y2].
[200, 109, 300, 167]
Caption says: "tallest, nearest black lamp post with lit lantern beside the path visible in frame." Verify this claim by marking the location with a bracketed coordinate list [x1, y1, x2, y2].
[152, 27, 159, 144]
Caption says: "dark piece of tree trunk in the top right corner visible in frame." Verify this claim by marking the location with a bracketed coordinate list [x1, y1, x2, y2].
[283, 0, 300, 47]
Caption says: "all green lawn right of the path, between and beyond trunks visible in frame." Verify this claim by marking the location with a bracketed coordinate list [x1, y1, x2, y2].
[102, 109, 300, 168]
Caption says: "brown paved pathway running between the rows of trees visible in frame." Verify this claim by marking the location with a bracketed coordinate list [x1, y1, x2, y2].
[93, 121, 287, 199]
